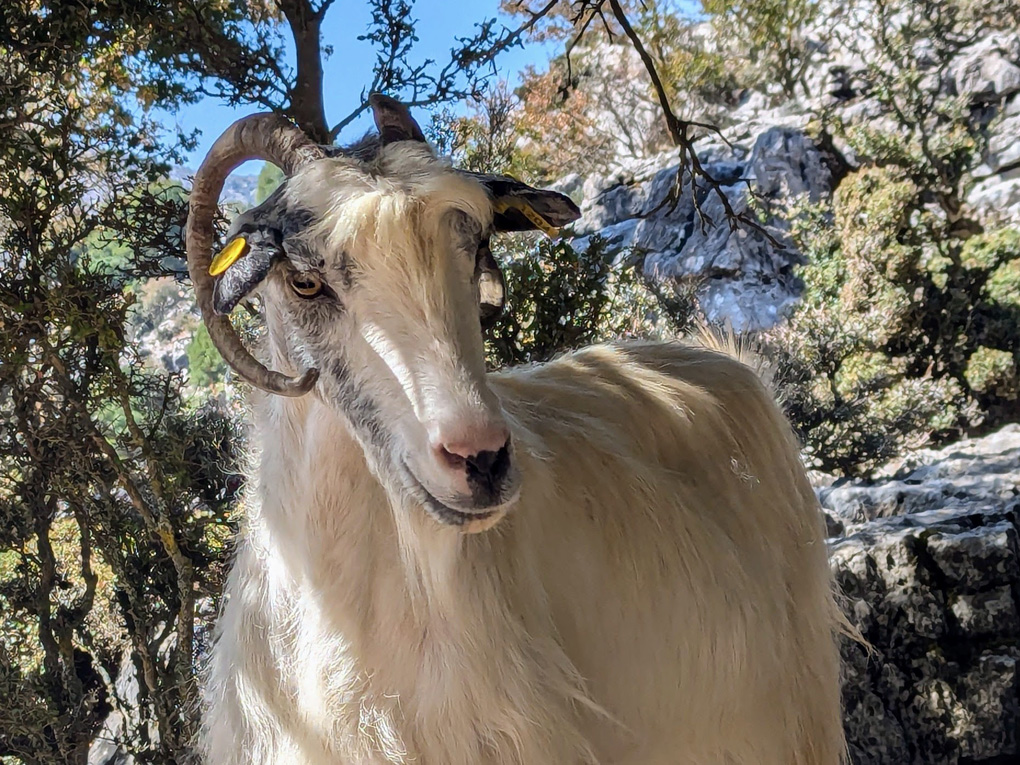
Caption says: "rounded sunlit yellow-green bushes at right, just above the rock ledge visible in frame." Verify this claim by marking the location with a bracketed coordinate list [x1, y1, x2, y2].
[771, 176, 1020, 474]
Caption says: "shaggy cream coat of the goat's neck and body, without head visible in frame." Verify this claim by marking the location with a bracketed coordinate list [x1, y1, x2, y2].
[200, 344, 843, 765]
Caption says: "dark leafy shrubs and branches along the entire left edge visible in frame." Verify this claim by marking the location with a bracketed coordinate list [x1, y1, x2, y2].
[0, 0, 250, 765]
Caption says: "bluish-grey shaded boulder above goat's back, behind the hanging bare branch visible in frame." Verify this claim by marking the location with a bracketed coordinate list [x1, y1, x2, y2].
[574, 126, 833, 332]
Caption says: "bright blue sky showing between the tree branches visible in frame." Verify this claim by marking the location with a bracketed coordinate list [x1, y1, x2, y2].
[163, 0, 552, 173]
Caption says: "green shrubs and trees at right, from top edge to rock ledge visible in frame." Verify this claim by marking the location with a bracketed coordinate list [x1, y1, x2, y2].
[758, 0, 1020, 474]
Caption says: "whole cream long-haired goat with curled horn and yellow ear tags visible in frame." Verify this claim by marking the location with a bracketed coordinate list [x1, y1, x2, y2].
[187, 94, 845, 765]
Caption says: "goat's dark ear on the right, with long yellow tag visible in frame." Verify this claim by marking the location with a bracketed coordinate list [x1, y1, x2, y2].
[475, 174, 580, 237]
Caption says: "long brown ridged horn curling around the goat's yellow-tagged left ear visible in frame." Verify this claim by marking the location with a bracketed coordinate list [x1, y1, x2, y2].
[185, 114, 325, 396]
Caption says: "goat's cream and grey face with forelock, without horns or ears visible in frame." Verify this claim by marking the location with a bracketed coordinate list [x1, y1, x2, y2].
[245, 153, 519, 528]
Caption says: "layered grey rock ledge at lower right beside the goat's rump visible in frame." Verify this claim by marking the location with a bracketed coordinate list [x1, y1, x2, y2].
[819, 425, 1020, 765]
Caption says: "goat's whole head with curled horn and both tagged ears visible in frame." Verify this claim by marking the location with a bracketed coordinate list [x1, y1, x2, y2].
[187, 95, 578, 530]
